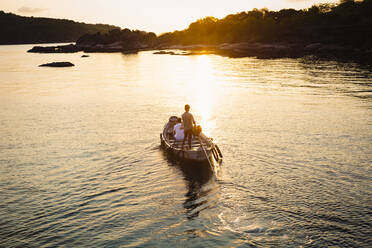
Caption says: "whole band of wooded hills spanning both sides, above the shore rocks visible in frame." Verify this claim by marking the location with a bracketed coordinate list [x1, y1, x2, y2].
[0, 0, 372, 48]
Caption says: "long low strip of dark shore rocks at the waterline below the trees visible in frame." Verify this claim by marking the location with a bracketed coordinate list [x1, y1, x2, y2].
[28, 42, 372, 64]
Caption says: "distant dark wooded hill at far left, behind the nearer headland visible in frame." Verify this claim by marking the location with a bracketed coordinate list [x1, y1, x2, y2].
[0, 11, 117, 44]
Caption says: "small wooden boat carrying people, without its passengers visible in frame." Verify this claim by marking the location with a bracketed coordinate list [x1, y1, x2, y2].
[160, 116, 222, 163]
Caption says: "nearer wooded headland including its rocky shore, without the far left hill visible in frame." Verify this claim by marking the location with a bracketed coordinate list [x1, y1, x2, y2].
[5, 0, 372, 63]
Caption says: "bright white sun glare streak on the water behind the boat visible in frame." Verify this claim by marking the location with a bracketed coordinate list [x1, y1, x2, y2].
[189, 55, 217, 134]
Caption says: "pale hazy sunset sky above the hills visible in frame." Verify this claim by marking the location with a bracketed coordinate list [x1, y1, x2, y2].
[0, 0, 337, 34]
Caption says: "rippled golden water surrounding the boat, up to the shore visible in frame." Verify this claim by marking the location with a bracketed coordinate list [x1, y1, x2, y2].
[0, 46, 372, 247]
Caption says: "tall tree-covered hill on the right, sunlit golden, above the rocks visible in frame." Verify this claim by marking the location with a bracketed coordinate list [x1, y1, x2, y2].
[157, 0, 372, 47]
